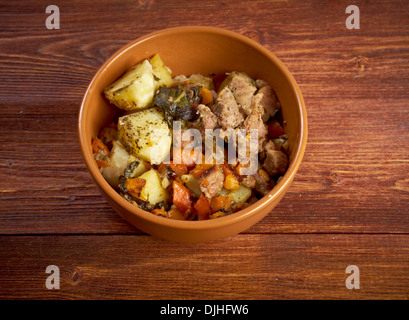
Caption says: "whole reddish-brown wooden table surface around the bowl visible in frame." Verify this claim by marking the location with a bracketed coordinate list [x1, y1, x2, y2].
[0, 0, 409, 299]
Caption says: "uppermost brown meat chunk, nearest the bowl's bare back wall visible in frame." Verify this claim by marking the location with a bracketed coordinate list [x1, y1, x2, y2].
[225, 72, 257, 115]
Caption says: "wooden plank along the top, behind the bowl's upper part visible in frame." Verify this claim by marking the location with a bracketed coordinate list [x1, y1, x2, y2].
[0, 1, 409, 103]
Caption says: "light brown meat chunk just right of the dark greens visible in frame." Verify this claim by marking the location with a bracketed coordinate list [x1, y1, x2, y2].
[212, 87, 244, 130]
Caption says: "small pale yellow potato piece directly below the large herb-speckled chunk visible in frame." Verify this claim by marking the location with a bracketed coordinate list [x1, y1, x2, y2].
[138, 169, 169, 205]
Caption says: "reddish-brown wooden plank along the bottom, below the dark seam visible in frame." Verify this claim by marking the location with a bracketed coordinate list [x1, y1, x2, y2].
[0, 234, 409, 299]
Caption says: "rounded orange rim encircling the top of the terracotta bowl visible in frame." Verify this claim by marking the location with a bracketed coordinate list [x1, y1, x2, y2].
[77, 26, 308, 230]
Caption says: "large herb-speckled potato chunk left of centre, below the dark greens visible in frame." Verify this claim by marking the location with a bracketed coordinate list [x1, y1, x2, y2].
[118, 108, 172, 164]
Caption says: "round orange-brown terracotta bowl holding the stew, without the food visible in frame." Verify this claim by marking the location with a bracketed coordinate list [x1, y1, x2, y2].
[78, 26, 307, 242]
